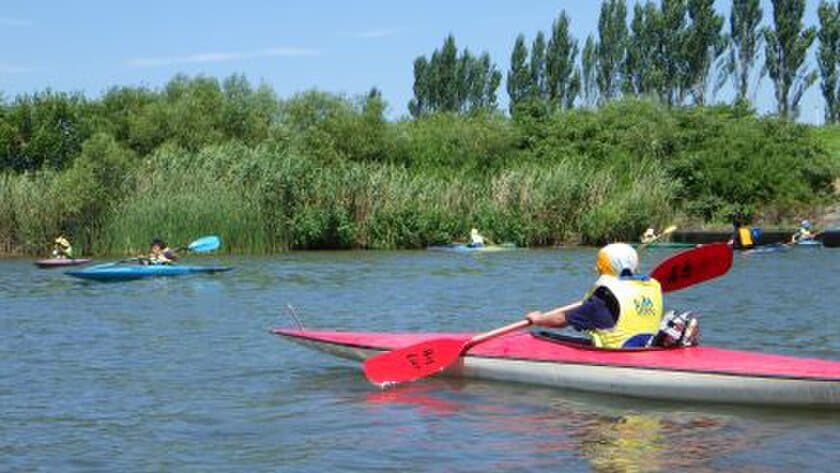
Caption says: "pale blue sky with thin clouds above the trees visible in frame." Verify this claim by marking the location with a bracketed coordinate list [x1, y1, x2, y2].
[0, 0, 822, 122]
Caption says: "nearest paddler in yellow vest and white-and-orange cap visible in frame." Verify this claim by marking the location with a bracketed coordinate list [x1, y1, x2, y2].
[526, 243, 662, 348]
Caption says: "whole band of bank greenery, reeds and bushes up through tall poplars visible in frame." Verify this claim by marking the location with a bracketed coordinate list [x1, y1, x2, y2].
[0, 0, 840, 254]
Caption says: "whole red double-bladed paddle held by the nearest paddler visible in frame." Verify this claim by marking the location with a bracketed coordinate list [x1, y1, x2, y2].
[363, 243, 732, 386]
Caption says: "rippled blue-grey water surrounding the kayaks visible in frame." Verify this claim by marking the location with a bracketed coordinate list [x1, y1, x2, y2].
[0, 249, 840, 472]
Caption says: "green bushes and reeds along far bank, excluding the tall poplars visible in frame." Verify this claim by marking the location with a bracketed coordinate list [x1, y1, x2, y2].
[0, 78, 840, 254]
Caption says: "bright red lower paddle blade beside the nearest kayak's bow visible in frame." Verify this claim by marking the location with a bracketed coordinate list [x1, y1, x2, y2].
[362, 338, 467, 386]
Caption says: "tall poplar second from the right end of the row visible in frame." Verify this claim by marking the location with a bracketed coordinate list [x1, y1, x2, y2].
[764, 0, 817, 118]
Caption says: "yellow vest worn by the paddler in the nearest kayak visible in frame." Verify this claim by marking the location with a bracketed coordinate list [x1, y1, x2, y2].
[587, 275, 662, 348]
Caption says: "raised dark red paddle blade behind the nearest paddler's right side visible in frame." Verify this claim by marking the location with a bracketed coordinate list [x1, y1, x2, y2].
[650, 243, 732, 292]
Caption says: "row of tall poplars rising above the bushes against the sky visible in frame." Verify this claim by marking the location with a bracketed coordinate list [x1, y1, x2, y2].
[409, 0, 840, 123]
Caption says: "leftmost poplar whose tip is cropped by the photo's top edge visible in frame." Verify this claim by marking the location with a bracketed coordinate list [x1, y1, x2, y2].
[584, 0, 628, 101]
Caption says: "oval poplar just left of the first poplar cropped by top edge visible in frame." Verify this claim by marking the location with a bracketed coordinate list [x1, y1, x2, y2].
[545, 11, 580, 109]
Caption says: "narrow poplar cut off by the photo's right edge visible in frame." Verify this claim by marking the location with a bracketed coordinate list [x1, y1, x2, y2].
[817, 0, 840, 123]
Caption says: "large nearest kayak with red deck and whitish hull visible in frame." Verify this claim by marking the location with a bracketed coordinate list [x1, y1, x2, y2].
[274, 329, 840, 409]
